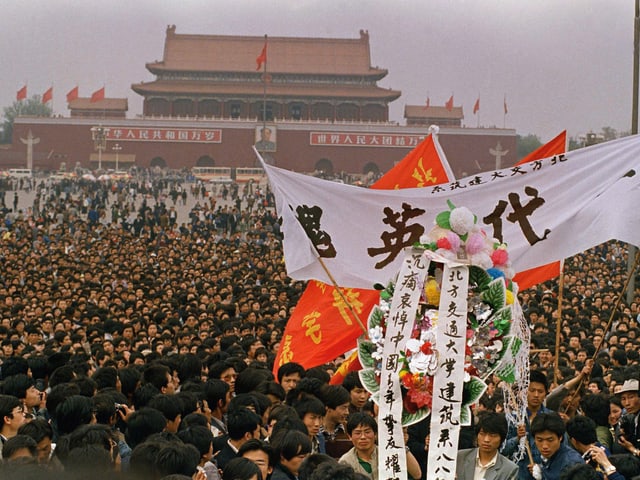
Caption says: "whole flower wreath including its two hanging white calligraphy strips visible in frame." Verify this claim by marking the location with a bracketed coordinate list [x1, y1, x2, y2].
[358, 204, 529, 480]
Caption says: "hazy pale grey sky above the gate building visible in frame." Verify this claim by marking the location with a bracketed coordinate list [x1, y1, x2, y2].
[0, 0, 634, 142]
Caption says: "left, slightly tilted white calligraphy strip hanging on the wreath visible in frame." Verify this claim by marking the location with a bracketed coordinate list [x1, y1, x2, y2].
[378, 249, 429, 480]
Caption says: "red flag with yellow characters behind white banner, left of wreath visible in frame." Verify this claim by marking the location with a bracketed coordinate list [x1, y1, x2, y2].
[273, 131, 454, 375]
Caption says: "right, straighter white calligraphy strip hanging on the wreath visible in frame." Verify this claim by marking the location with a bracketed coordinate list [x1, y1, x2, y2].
[427, 264, 469, 480]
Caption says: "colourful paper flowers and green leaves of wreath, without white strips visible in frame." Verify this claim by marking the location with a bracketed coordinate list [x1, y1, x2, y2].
[358, 202, 523, 425]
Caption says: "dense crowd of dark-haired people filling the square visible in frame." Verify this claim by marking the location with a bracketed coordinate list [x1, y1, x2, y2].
[0, 173, 640, 480]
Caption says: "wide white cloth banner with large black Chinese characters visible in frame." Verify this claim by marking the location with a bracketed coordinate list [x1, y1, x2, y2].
[256, 135, 640, 288]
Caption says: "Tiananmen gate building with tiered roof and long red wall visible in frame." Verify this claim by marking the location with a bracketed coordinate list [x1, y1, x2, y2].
[5, 26, 516, 177]
